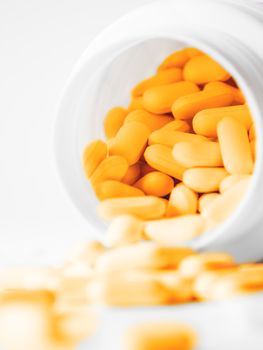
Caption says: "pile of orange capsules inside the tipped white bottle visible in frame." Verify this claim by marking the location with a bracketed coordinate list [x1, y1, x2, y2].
[83, 48, 256, 245]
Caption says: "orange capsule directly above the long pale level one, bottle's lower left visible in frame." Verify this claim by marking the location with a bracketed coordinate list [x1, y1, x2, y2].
[94, 180, 144, 200]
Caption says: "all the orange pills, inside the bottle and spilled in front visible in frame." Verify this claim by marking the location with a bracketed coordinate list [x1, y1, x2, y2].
[0, 48, 263, 350]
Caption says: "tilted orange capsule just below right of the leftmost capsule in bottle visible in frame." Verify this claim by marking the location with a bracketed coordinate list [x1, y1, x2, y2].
[90, 156, 129, 186]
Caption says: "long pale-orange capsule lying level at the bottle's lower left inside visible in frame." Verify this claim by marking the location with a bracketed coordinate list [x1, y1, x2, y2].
[98, 196, 166, 220]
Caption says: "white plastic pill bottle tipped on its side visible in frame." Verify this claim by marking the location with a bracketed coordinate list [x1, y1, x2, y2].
[54, 0, 263, 261]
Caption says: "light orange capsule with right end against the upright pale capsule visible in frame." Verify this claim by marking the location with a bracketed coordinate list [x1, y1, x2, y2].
[172, 142, 223, 168]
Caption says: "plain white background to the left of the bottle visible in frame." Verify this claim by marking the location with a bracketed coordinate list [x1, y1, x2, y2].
[0, 0, 151, 265]
